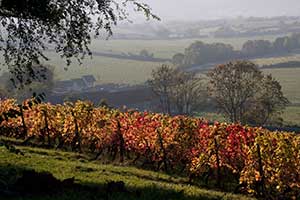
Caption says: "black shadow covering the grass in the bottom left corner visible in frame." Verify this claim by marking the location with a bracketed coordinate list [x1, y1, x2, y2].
[0, 165, 220, 200]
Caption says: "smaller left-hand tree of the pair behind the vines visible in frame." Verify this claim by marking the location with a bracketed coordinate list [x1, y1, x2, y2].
[148, 65, 204, 115]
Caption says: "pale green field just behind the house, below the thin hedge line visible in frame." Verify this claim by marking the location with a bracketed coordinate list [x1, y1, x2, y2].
[42, 53, 161, 84]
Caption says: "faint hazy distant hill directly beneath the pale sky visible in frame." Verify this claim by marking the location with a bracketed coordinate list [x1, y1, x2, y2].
[113, 16, 300, 39]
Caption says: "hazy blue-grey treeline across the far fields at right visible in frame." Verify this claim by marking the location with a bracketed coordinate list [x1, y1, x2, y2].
[172, 33, 300, 66]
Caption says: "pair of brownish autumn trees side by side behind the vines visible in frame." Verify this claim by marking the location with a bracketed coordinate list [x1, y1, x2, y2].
[148, 61, 289, 126]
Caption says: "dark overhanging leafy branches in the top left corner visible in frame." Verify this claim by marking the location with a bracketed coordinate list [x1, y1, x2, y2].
[0, 0, 159, 86]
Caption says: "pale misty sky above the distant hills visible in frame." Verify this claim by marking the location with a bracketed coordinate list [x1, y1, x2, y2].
[137, 0, 300, 21]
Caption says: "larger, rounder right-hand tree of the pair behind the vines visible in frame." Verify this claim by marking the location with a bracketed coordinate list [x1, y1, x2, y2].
[208, 61, 288, 125]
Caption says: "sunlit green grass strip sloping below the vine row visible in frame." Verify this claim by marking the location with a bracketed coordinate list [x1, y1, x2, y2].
[0, 147, 255, 200]
